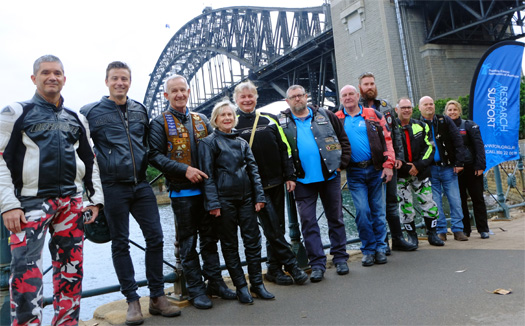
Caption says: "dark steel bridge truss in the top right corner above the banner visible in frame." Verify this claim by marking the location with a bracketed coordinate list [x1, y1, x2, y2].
[400, 0, 525, 45]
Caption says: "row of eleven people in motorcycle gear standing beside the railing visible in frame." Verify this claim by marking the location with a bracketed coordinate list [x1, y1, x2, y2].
[0, 55, 489, 325]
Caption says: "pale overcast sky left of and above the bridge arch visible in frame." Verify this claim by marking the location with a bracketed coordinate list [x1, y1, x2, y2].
[0, 0, 323, 110]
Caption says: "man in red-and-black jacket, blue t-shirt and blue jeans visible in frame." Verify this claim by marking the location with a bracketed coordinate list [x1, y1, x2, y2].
[336, 85, 394, 266]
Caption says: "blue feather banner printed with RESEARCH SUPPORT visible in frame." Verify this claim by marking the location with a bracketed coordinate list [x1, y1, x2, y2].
[470, 41, 524, 171]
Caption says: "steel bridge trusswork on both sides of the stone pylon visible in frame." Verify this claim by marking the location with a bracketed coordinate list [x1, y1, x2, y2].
[144, 0, 525, 117]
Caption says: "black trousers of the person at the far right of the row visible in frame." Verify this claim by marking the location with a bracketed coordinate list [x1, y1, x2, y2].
[458, 165, 489, 233]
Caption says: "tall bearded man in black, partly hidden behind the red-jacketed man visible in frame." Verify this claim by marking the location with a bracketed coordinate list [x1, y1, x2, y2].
[359, 72, 417, 252]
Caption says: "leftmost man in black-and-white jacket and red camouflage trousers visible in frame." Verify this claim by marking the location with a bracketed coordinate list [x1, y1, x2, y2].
[0, 55, 104, 325]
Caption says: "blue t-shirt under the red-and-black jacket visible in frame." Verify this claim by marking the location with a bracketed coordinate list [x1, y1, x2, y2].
[343, 106, 372, 163]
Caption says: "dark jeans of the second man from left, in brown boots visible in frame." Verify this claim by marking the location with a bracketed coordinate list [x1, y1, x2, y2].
[102, 181, 164, 302]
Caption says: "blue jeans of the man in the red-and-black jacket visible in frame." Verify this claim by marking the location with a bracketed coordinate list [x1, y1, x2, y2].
[346, 166, 387, 255]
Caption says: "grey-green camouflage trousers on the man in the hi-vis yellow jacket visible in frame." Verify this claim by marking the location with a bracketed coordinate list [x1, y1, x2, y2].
[397, 176, 439, 224]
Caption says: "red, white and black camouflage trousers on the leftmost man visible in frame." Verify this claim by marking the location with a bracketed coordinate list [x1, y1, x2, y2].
[9, 194, 84, 326]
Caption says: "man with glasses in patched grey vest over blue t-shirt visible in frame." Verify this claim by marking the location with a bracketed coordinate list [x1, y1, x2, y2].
[278, 85, 350, 282]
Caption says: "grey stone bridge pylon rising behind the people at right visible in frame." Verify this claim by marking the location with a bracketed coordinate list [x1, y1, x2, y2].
[330, 0, 490, 104]
